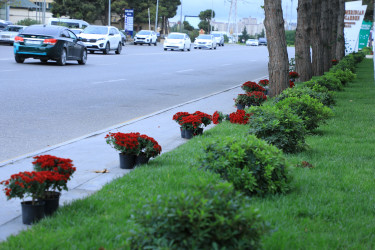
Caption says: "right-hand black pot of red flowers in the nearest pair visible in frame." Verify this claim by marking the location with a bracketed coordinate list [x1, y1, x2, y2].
[32, 155, 76, 215]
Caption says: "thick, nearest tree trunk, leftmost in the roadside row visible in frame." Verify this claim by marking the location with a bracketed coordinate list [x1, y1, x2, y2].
[264, 0, 289, 97]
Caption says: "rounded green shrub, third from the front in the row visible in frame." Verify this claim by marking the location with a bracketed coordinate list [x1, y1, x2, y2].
[248, 105, 306, 153]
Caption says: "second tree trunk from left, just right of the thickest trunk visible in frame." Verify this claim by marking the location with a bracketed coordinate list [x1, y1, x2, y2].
[295, 0, 312, 82]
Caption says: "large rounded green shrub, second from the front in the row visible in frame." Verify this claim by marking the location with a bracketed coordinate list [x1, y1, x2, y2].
[201, 135, 290, 196]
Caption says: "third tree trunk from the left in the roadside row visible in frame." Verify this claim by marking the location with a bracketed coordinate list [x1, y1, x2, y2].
[311, 0, 324, 76]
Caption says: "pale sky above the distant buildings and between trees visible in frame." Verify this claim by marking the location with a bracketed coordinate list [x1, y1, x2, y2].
[169, 0, 298, 27]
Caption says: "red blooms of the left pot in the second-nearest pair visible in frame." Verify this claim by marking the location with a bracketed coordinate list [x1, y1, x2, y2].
[105, 132, 140, 155]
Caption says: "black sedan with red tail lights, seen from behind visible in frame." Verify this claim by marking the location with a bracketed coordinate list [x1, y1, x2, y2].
[13, 25, 87, 65]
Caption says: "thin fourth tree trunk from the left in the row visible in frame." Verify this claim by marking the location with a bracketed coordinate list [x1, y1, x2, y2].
[320, 0, 332, 72]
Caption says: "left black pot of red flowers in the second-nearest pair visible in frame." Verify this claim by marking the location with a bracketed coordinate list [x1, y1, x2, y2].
[105, 132, 140, 169]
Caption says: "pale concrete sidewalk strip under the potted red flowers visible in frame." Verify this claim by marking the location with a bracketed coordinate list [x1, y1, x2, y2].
[0, 79, 260, 241]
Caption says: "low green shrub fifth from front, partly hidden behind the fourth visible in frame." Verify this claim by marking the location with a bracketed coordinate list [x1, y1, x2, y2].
[273, 84, 335, 107]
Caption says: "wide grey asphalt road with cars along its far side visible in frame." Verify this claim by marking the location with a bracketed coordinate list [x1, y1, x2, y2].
[0, 44, 294, 162]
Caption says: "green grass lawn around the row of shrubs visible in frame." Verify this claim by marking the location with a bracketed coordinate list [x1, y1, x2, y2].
[0, 59, 375, 249]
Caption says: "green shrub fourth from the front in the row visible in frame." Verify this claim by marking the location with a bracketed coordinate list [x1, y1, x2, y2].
[275, 95, 333, 131]
